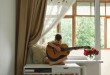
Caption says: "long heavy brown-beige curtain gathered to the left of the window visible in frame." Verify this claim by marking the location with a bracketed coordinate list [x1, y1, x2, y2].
[15, 0, 47, 75]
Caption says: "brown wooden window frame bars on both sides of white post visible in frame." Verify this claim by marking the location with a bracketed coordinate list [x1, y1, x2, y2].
[43, 0, 110, 50]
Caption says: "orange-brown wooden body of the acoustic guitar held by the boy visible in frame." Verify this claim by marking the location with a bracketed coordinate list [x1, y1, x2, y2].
[46, 44, 70, 60]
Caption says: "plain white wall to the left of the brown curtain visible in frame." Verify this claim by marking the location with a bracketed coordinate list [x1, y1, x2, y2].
[0, 0, 16, 75]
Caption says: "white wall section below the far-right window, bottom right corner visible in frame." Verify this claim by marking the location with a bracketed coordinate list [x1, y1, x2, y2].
[101, 50, 110, 75]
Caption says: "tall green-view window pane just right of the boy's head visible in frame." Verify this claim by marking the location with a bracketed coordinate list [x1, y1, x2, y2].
[60, 19, 72, 46]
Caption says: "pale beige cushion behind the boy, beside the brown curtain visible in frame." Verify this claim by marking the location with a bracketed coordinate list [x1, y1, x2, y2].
[31, 44, 46, 64]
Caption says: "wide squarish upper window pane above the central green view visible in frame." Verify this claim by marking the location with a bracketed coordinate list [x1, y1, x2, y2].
[76, 2, 90, 15]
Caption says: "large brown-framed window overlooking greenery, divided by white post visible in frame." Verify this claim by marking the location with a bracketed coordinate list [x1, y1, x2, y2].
[43, 0, 110, 56]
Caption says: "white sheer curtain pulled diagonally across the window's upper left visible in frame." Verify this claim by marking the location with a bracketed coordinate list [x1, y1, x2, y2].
[41, 0, 76, 38]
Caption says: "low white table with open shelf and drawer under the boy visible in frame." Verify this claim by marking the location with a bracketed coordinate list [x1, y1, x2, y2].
[24, 63, 81, 75]
